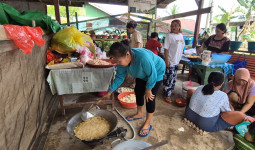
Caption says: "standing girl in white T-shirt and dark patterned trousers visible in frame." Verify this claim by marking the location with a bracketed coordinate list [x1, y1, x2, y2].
[163, 20, 184, 103]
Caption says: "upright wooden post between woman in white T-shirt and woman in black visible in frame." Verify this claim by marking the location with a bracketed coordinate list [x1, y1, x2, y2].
[192, 0, 204, 48]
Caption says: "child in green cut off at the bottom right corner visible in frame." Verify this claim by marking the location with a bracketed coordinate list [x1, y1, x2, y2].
[234, 122, 255, 150]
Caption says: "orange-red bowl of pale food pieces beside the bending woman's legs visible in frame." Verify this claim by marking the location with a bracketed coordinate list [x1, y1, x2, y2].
[118, 92, 137, 108]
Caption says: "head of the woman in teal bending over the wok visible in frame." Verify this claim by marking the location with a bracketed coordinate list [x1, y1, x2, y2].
[108, 40, 131, 66]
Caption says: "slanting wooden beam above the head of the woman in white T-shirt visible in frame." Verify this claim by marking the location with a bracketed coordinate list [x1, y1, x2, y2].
[157, 7, 212, 21]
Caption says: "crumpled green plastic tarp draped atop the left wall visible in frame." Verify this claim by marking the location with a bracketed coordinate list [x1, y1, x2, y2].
[0, 2, 61, 33]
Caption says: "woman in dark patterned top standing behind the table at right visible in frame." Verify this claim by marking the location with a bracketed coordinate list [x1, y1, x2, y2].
[198, 23, 230, 53]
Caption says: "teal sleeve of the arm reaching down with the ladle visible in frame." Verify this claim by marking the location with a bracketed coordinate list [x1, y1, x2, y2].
[109, 65, 127, 93]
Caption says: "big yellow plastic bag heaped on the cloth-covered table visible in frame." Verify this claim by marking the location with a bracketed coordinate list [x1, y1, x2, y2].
[51, 27, 94, 53]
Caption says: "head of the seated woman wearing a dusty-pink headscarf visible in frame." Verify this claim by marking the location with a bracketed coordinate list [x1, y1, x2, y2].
[234, 68, 250, 86]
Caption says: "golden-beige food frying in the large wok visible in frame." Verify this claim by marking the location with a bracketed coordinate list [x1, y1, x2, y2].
[74, 116, 110, 140]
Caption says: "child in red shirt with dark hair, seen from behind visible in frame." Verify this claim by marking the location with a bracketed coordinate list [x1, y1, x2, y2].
[145, 32, 161, 55]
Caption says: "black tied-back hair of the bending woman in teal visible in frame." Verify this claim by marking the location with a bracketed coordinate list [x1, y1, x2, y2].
[108, 40, 131, 58]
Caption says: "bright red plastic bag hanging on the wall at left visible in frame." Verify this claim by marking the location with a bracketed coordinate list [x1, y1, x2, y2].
[3, 25, 45, 54]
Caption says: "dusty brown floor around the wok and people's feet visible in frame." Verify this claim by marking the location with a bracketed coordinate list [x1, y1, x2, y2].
[44, 71, 234, 150]
